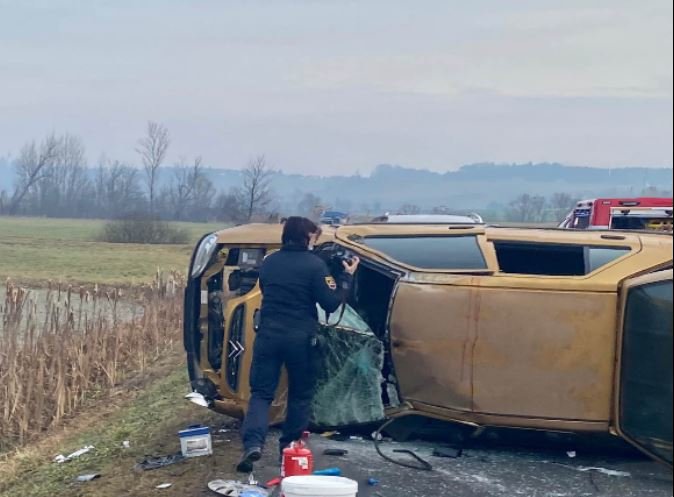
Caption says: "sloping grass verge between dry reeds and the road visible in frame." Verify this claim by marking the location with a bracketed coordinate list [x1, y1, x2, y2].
[0, 353, 233, 497]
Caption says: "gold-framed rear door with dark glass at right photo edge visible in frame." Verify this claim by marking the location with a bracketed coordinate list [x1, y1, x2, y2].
[615, 270, 673, 465]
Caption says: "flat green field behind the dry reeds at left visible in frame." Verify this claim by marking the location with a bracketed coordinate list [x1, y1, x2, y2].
[0, 217, 223, 285]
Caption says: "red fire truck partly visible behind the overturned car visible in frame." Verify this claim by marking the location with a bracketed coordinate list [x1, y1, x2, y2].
[559, 197, 674, 231]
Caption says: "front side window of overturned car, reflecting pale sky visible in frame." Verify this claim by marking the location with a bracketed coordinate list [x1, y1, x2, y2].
[362, 235, 487, 270]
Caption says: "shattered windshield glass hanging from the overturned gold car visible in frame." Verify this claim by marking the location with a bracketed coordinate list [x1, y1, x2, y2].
[312, 305, 384, 427]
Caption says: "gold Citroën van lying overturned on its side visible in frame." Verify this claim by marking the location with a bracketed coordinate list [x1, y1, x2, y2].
[185, 224, 673, 464]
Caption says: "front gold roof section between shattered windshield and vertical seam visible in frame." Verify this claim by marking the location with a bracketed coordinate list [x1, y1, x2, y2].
[390, 275, 481, 412]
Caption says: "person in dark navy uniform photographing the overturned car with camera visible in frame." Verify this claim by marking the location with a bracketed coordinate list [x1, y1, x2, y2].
[237, 217, 360, 473]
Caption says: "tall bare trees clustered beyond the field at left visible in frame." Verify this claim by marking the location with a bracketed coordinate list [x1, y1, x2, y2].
[0, 122, 278, 222]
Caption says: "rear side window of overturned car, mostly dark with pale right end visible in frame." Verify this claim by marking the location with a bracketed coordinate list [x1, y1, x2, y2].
[494, 241, 630, 276]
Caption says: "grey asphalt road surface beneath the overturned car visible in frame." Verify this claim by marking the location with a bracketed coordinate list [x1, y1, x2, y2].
[249, 428, 672, 497]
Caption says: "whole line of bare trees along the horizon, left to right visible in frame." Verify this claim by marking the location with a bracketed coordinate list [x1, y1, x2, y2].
[0, 122, 671, 227]
